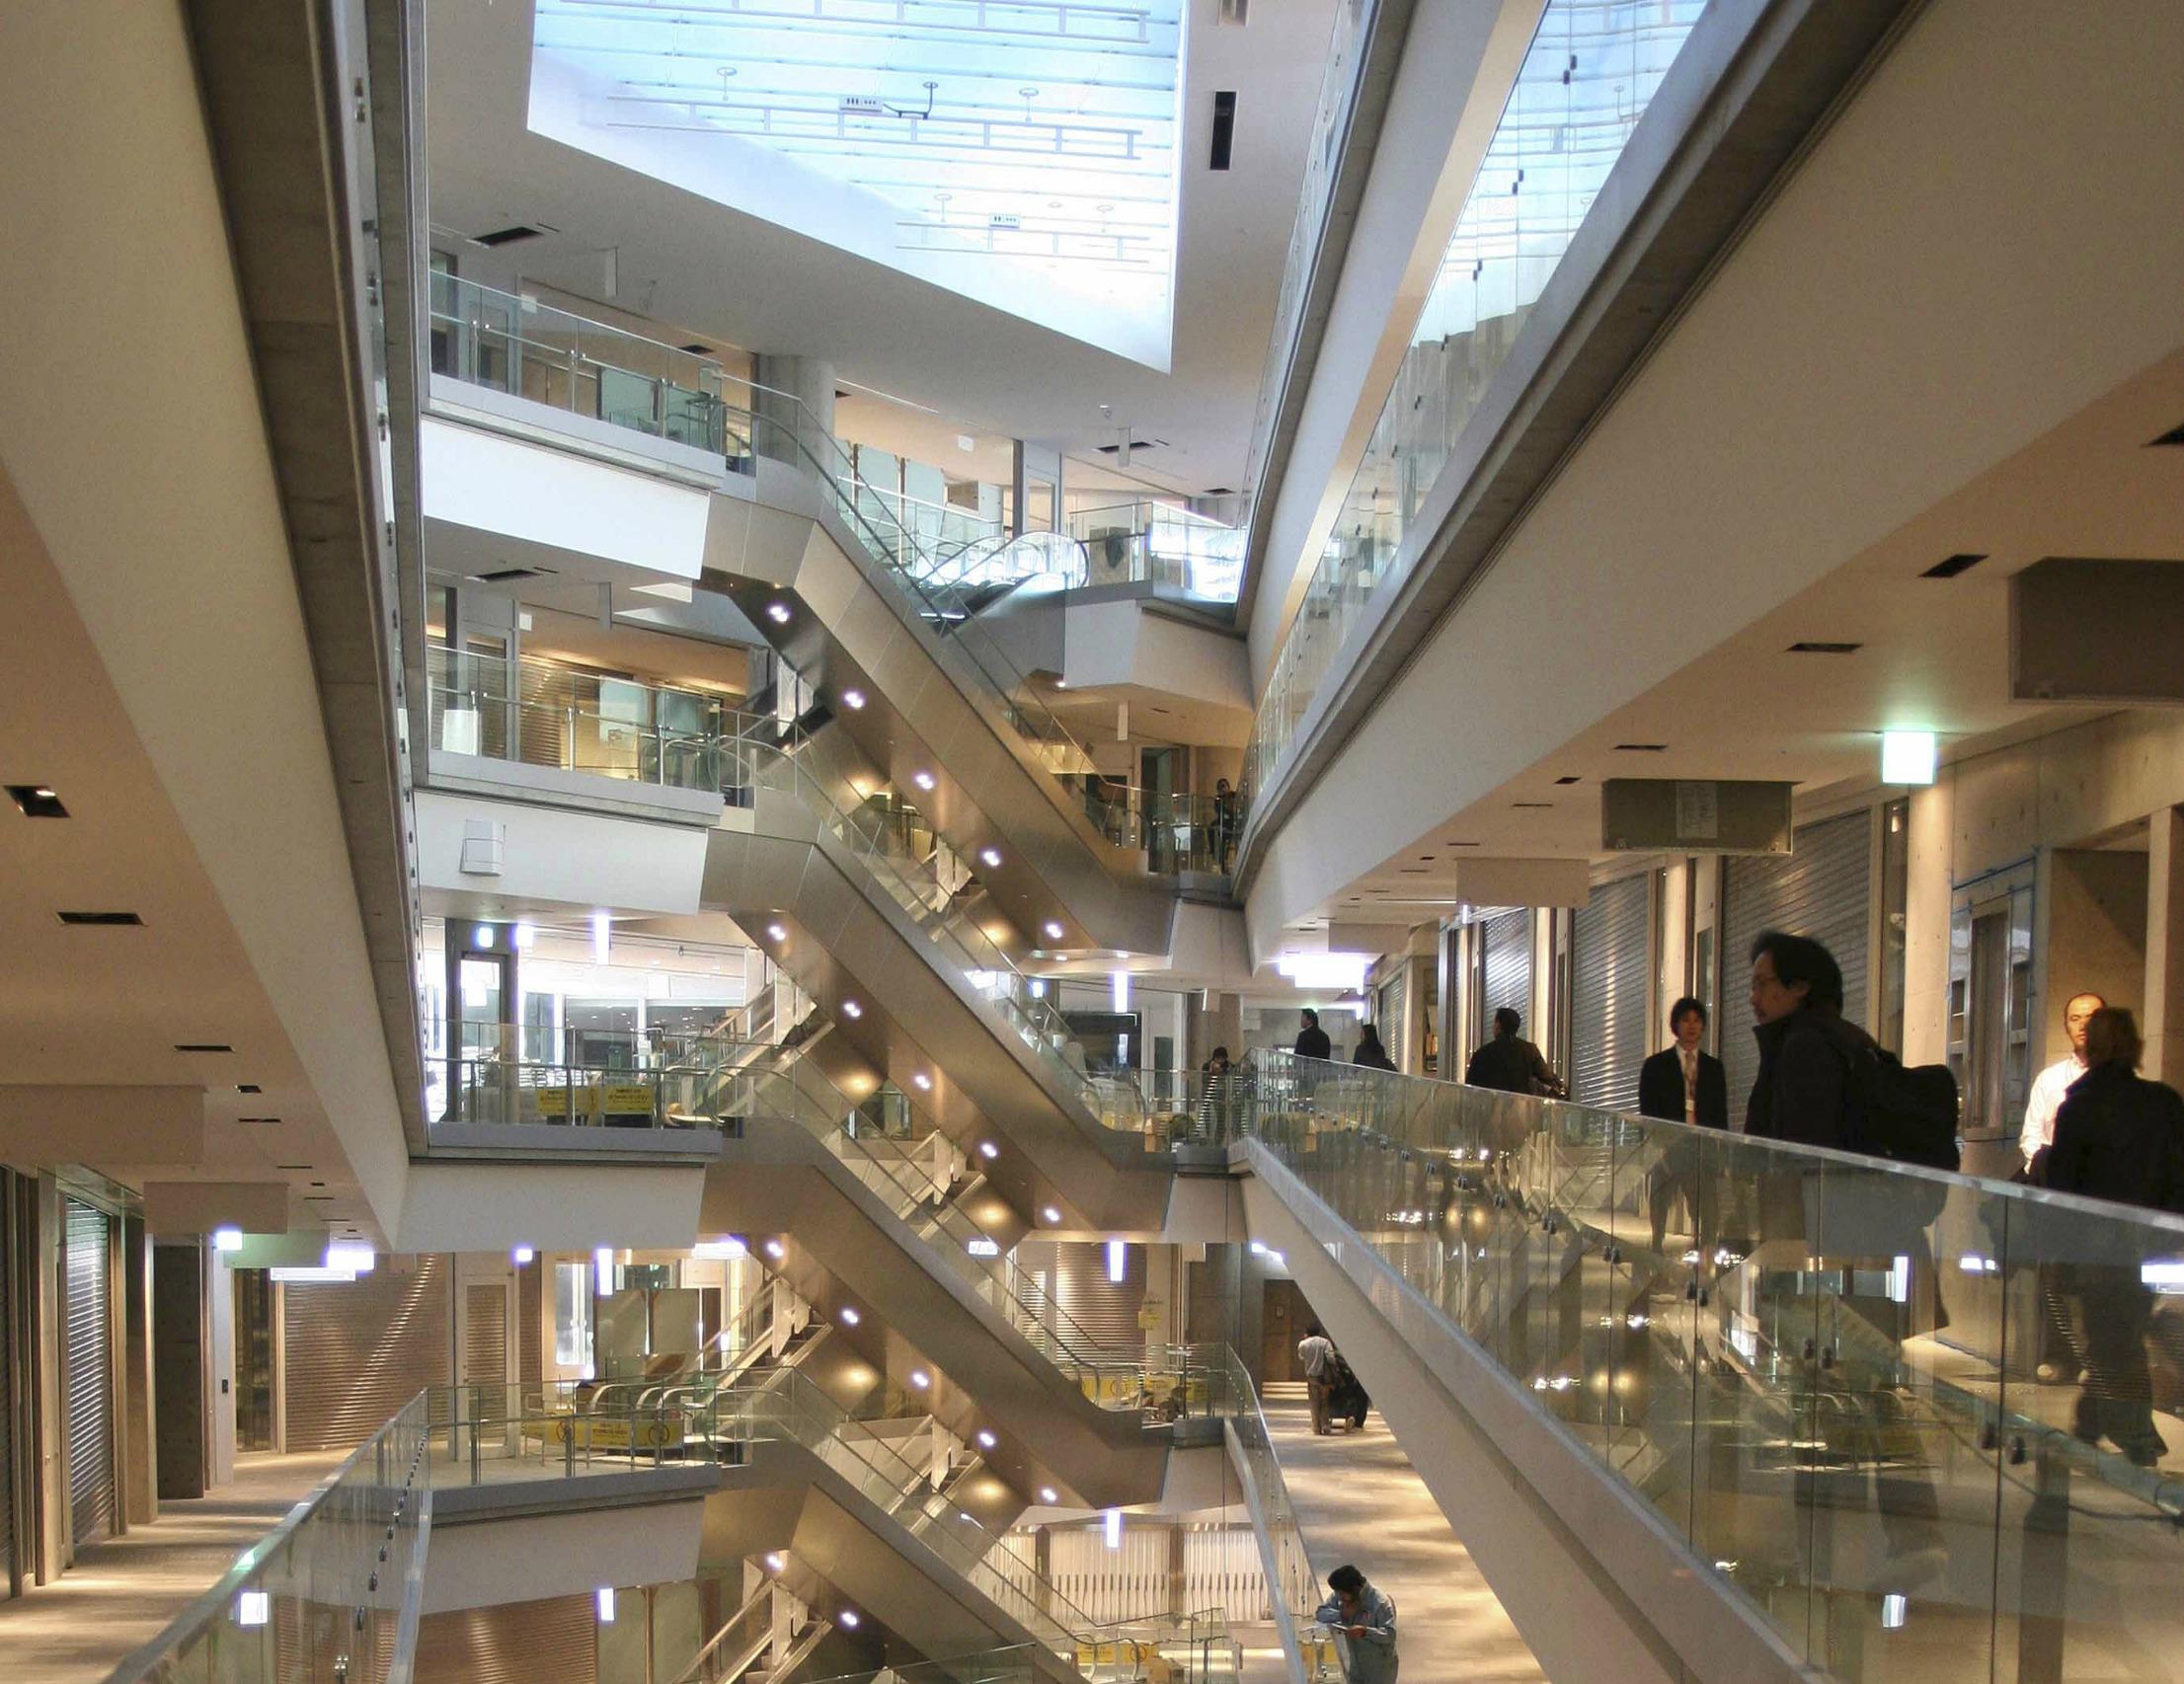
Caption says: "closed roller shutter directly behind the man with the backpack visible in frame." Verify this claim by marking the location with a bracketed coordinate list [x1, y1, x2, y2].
[1721, 812, 1874, 1127]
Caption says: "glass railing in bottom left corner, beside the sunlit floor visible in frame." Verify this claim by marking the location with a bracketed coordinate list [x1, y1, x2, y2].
[110, 1394, 430, 1684]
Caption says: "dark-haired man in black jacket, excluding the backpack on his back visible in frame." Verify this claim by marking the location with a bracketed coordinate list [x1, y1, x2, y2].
[1745, 931, 1874, 1151]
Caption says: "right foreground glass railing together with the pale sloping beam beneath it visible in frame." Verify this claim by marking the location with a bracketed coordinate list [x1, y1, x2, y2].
[1236, 1055, 2184, 1680]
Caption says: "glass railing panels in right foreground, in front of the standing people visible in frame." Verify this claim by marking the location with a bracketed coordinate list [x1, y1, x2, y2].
[1247, 1053, 2184, 1684]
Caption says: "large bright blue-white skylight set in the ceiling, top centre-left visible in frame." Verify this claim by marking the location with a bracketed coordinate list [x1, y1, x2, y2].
[531, 0, 1182, 367]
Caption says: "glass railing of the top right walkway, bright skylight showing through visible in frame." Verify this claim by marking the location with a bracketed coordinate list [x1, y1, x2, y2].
[1243, 0, 1706, 800]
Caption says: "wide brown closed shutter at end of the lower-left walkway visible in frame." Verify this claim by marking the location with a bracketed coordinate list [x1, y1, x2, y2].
[281, 1254, 454, 1450]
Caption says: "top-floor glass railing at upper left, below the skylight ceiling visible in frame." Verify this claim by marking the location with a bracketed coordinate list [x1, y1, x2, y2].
[430, 273, 751, 461]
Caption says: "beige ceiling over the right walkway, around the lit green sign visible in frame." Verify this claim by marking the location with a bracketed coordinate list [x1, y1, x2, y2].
[1293, 353, 2184, 924]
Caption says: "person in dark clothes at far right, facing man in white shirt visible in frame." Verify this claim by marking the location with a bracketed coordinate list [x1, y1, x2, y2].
[2047, 1005, 2184, 1468]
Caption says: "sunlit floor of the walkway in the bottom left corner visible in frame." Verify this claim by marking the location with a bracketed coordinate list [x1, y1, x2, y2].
[0, 1452, 343, 1684]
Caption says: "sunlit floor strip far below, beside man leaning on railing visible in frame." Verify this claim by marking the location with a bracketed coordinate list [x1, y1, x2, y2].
[1265, 1383, 1546, 1684]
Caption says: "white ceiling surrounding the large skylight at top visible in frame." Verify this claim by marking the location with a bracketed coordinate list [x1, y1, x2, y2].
[429, 0, 1335, 494]
